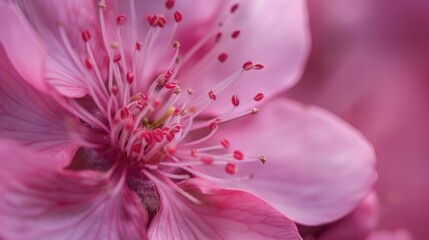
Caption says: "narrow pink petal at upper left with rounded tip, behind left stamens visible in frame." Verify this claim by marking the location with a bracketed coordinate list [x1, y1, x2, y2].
[14, 0, 103, 97]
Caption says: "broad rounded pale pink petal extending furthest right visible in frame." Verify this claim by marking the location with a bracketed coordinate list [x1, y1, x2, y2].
[197, 99, 376, 225]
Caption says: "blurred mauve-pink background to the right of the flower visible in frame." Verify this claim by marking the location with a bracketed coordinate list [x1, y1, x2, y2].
[287, 0, 429, 240]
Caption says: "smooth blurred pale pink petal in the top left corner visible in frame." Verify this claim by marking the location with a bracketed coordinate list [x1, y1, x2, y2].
[0, 1, 47, 92]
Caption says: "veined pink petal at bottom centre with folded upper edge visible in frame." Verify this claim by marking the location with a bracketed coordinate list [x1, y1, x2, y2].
[148, 179, 301, 240]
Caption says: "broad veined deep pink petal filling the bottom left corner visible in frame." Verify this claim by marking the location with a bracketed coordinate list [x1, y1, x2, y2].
[0, 140, 146, 240]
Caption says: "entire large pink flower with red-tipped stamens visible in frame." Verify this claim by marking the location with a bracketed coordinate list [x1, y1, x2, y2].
[0, 0, 375, 239]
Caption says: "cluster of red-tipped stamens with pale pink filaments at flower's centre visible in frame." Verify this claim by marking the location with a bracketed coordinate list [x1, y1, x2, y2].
[59, 0, 266, 184]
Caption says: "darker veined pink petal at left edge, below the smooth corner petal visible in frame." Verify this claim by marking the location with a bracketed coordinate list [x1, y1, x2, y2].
[0, 47, 81, 157]
